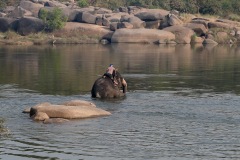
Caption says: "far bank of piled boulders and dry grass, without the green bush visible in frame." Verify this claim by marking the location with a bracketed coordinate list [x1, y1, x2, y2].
[0, 0, 240, 45]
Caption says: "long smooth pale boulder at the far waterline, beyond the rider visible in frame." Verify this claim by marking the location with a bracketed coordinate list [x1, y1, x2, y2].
[111, 29, 175, 43]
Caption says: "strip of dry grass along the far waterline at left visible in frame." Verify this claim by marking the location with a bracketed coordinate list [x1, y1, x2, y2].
[0, 30, 100, 45]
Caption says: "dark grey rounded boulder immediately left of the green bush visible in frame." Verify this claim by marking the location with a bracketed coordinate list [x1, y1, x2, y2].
[17, 17, 44, 36]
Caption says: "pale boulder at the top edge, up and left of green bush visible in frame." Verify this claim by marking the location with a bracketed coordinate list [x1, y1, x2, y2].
[19, 1, 44, 17]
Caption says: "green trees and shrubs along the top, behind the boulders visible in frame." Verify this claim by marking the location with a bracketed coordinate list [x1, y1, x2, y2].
[0, 0, 240, 20]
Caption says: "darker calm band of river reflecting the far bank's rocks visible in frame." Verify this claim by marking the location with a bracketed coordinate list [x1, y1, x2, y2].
[0, 44, 240, 95]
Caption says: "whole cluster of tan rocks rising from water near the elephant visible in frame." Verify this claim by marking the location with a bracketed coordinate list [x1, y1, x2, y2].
[23, 100, 111, 123]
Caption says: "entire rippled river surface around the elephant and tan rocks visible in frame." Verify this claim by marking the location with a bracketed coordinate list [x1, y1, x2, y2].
[0, 44, 240, 160]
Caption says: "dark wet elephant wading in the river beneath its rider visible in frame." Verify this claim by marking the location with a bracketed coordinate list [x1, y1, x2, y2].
[91, 70, 127, 99]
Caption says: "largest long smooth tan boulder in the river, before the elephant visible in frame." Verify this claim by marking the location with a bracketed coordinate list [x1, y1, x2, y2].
[30, 100, 111, 120]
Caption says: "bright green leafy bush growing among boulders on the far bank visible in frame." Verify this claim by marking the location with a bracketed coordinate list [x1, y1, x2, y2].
[39, 8, 67, 32]
